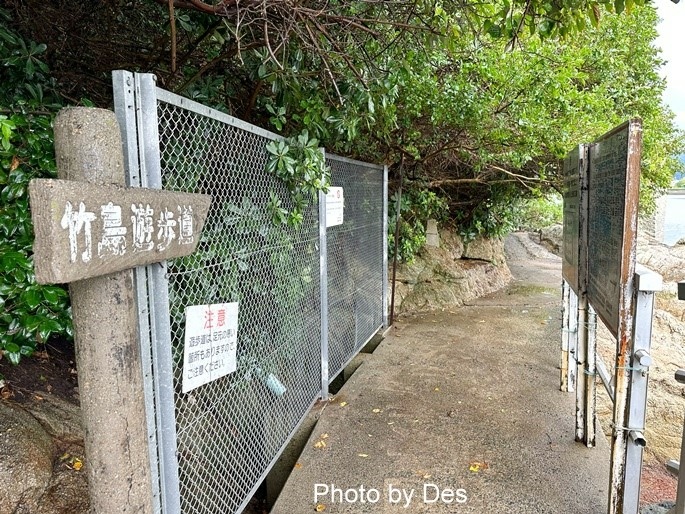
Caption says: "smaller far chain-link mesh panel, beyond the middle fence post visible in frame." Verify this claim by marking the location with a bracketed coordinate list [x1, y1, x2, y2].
[326, 154, 385, 380]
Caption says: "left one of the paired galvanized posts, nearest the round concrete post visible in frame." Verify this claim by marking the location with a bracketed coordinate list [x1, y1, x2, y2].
[112, 70, 161, 512]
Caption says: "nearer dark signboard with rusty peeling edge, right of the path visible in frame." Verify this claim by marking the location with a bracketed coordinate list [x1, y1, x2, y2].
[587, 120, 642, 336]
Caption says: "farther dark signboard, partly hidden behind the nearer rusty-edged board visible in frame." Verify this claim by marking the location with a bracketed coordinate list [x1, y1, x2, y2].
[561, 146, 585, 294]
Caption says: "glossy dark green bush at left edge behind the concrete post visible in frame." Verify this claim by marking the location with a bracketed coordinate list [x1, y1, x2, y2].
[0, 9, 72, 364]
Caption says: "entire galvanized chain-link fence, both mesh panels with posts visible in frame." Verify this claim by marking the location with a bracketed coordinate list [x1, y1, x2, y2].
[114, 71, 387, 514]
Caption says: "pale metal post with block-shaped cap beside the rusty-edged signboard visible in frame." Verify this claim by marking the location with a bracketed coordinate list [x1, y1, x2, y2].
[623, 265, 662, 513]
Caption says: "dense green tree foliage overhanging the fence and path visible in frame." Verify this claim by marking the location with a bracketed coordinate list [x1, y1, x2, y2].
[0, 0, 685, 361]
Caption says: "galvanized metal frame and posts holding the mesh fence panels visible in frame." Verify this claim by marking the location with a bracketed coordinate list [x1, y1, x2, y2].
[112, 70, 388, 514]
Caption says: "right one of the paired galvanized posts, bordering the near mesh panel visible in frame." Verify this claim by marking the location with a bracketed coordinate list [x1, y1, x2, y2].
[134, 73, 181, 513]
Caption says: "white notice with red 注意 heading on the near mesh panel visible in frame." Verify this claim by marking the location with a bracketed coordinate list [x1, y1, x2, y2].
[182, 302, 238, 393]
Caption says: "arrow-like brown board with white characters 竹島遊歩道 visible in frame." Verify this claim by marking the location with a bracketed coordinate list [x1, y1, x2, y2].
[29, 179, 211, 284]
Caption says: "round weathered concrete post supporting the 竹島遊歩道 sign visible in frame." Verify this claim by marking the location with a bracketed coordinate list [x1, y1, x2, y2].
[55, 108, 152, 508]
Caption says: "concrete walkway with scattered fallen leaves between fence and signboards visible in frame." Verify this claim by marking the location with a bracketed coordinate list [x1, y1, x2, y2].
[271, 234, 609, 514]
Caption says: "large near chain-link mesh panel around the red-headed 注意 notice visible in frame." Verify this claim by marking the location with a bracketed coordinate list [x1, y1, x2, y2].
[152, 93, 321, 514]
